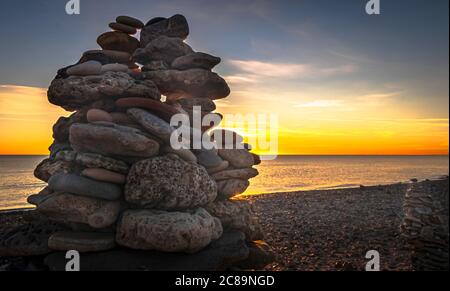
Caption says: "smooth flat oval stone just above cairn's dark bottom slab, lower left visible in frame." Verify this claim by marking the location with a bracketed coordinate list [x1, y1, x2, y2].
[48, 231, 116, 253]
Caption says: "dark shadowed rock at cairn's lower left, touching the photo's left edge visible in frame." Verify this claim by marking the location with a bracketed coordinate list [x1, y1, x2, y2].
[0, 221, 66, 257]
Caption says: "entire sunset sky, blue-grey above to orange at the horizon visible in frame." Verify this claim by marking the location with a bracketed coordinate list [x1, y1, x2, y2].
[0, 0, 449, 155]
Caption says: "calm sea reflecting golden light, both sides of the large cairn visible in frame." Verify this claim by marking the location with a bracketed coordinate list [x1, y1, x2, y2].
[0, 156, 449, 209]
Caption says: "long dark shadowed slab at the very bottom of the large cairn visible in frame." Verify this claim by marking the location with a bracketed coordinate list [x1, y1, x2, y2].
[45, 231, 249, 272]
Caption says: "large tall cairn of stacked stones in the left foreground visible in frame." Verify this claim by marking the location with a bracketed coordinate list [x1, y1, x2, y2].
[0, 15, 271, 270]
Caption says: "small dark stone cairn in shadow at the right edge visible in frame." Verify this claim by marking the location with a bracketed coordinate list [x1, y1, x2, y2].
[400, 178, 449, 271]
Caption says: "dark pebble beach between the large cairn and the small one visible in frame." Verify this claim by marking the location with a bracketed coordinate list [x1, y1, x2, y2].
[249, 184, 412, 271]
